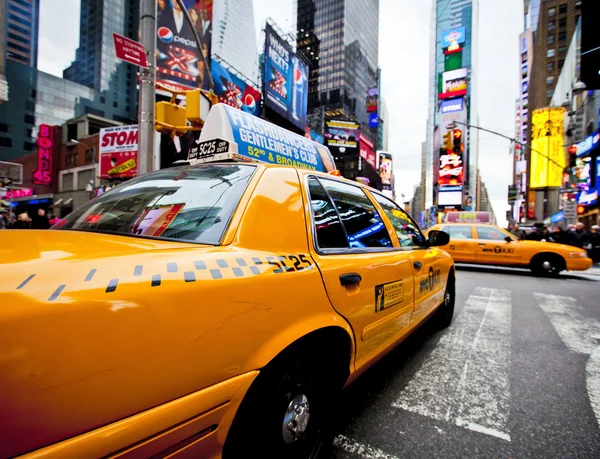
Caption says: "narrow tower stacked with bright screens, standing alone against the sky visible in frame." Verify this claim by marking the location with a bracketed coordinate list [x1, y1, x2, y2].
[424, 0, 479, 217]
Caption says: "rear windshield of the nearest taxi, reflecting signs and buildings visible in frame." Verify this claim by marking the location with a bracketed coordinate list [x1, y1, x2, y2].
[53, 164, 256, 245]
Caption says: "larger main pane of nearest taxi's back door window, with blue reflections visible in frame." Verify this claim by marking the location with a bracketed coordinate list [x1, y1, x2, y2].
[320, 180, 392, 249]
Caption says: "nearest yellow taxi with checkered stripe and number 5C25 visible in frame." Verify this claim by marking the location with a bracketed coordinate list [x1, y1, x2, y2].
[0, 105, 455, 459]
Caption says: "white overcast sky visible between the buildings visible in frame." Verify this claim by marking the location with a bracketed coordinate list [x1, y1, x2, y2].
[38, 0, 523, 223]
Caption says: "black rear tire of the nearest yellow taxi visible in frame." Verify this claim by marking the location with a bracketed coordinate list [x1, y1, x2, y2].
[223, 346, 342, 459]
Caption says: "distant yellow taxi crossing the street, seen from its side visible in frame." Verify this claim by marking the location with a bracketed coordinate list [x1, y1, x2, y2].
[430, 222, 592, 276]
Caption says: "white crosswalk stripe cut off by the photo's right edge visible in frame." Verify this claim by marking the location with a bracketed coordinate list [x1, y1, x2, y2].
[533, 293, 600, 426]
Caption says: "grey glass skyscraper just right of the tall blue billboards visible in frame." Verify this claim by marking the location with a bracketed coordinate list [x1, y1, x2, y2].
[296, 0, 380, 184]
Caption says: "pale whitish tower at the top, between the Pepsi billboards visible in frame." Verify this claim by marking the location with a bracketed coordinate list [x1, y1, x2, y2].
[212, 0, 258, 84]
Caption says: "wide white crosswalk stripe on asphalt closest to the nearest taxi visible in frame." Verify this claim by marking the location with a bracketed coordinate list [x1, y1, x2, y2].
[392, 287, 511, 441]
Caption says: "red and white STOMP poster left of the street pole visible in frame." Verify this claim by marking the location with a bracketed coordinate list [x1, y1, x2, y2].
[99, 124, 138, 179]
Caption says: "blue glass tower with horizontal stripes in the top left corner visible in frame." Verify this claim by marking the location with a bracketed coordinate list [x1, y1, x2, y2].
[2, 0, 40, 67]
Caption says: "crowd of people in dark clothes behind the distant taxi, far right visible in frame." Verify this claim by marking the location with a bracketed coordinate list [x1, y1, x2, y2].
[508, 222, 600, 263]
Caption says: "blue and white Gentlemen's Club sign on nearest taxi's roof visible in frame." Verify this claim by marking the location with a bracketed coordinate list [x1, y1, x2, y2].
[195, 104, 335, 172]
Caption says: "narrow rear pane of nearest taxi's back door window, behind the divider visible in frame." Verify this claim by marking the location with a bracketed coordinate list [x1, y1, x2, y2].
[308, 178, 348, 249]
